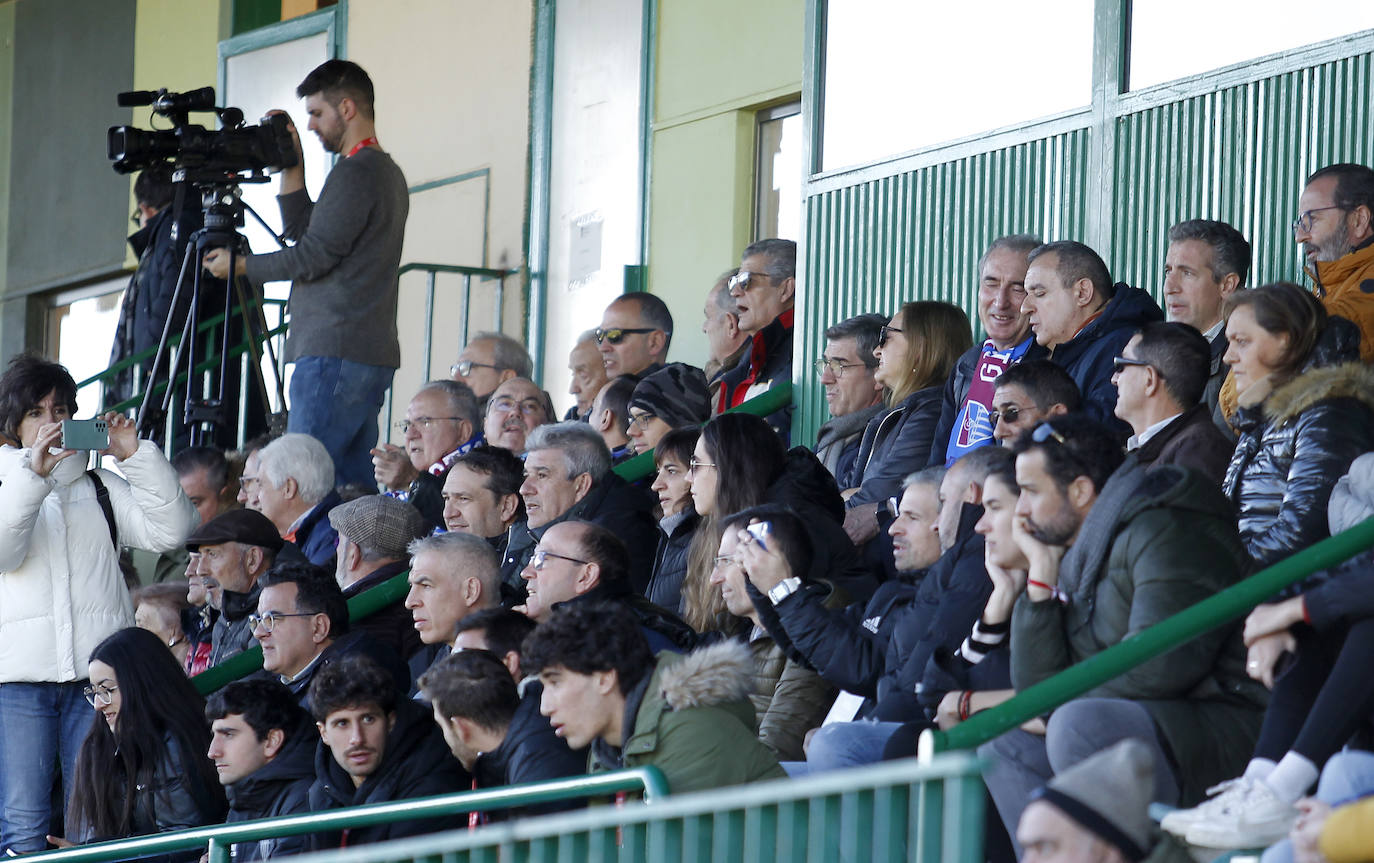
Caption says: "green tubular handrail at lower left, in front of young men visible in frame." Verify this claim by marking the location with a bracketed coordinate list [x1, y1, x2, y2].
[25, 767, 668, 863]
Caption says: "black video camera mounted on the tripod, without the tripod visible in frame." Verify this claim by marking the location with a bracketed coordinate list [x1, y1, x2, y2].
[109, 87, 295, 181]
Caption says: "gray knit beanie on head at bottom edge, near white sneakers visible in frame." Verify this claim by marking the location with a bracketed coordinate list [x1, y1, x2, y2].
[1031, 739, 1156, 863]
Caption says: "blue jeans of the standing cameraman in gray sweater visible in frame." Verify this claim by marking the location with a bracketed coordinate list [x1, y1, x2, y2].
[286, 356, 396, 488]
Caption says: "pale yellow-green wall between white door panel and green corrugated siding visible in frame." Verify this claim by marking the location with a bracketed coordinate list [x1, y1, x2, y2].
[649, 0, 805, 364]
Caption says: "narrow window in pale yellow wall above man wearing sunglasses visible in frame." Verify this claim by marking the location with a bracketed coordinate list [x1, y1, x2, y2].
[754, 102, 801, 239]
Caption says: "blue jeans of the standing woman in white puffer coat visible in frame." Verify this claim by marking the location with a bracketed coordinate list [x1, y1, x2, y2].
[0, 680, 99, 853]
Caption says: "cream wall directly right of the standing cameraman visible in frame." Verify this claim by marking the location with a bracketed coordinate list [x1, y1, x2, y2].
[345, 0, 532, 434]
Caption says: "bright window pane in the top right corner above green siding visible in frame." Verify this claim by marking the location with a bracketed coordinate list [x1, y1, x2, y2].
[1129, 0, 1374, 89]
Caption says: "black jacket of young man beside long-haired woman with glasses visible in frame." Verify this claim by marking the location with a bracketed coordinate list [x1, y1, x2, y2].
[224, 720, 320, 863]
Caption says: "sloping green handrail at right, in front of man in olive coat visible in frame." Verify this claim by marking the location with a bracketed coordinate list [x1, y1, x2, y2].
[921, 518, 1374, 757]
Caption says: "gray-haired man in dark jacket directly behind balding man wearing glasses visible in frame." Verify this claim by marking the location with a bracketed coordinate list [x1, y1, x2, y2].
[502, 422, 658, 595]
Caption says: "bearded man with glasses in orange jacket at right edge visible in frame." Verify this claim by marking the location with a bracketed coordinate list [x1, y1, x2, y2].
[1293, 164, 1374, 363]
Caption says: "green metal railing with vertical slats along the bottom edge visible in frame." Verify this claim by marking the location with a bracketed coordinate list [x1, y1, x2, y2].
[284, 753, 984, 863]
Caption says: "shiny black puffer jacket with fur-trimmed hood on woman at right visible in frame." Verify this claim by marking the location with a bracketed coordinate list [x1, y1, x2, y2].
[1223, 363, 1374, 568]
